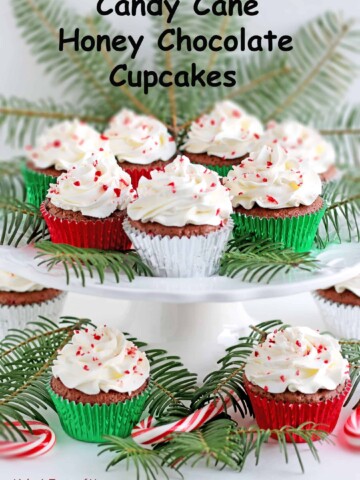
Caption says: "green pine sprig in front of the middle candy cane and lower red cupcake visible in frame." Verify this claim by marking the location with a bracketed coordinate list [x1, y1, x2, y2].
[99, 418, 331, 480]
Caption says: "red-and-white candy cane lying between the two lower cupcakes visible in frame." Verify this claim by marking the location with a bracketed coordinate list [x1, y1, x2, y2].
[131, 397, 236, 445]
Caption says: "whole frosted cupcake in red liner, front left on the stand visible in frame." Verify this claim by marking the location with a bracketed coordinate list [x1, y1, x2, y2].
[40, 150, 136, 250]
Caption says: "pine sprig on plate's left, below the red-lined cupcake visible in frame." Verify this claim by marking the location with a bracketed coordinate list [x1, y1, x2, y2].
[35, 241, 152, 286]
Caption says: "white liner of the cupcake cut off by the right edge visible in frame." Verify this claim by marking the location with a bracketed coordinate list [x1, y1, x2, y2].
[313, 292, 360, 339]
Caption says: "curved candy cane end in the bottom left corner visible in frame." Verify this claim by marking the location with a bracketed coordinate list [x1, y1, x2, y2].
[0, 421, 56, 459]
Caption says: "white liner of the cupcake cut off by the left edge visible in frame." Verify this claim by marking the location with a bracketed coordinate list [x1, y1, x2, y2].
[0, 293, 66, 339]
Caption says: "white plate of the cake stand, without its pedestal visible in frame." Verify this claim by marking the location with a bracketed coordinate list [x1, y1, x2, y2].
[0, 243, 360, 303]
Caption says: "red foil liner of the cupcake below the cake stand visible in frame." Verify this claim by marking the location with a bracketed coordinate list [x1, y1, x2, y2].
[245, 381, 351, 443]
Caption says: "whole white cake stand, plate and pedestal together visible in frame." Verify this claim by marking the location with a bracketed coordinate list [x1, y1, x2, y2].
[0, 243, 360, 370]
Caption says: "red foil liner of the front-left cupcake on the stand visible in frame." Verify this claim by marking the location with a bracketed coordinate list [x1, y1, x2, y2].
[40, 202, 131, 250]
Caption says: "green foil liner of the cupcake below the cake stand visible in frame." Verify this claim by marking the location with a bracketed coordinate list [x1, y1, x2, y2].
[48, 385, 151, 443]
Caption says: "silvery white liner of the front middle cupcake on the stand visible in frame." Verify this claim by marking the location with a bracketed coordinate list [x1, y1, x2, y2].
[123, 219, 233, 277]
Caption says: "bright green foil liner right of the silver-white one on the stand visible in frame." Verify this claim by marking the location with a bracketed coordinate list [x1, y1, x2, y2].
[232, 205, 326, 252]
